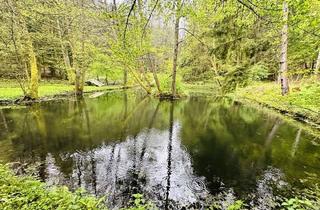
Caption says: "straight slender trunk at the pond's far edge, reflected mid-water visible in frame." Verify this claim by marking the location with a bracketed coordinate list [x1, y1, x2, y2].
[171, 0, 180, 97]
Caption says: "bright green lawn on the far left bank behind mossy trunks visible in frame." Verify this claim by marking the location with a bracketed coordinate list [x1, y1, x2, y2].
[0, 80, 121, 100]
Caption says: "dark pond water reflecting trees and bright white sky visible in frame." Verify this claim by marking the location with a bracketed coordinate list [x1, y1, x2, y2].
[0, 92, 320, 209]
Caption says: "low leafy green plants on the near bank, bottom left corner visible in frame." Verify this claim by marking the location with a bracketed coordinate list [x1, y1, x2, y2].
[0, 165, 106, 210]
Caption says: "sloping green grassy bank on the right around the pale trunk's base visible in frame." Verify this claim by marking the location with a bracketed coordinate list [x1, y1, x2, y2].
[233, 80, 320, 128]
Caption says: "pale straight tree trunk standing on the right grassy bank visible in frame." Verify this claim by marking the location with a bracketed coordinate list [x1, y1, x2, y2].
[280, 1, 289, 95]
